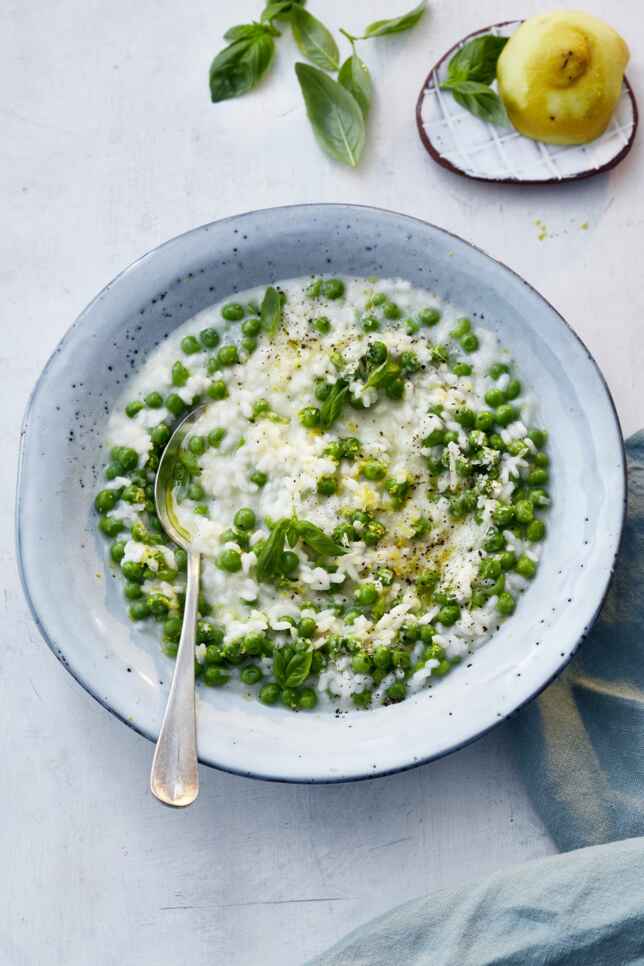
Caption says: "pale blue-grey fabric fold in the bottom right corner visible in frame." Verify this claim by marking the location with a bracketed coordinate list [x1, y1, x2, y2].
[309, 838, 644, 966]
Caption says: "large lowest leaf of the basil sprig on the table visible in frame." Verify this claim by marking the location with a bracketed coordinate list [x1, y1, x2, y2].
[295, 64, 365, 168]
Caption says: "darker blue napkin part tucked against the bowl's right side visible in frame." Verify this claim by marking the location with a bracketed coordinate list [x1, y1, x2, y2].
[506, 432, 644, 852]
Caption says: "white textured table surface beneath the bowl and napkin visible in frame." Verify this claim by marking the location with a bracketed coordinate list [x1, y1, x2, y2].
[0, 0, 644, 966]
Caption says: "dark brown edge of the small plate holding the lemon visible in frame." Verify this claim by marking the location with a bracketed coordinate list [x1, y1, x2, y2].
[416, 20, 639, 186]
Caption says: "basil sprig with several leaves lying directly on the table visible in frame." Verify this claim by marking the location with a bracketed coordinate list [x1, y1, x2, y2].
[210, 0, 427, 167]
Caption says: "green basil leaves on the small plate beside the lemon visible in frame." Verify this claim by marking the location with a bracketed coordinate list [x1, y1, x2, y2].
[441, 34, 508, 126]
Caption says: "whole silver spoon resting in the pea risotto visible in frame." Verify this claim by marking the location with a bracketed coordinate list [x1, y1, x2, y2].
[150, 406, 205, 808]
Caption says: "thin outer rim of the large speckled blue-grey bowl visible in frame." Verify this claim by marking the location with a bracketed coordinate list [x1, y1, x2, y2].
[15, 202, 627, 785]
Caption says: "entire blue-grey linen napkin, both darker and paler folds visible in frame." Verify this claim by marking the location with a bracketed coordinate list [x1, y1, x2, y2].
[310, 432, 644, 966]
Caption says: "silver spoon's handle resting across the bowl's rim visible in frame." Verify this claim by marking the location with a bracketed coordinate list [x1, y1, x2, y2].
[150, 553, 201, 808]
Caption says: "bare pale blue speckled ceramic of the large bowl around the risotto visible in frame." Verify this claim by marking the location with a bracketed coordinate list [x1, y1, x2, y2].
[17, 205, 625, 782]
